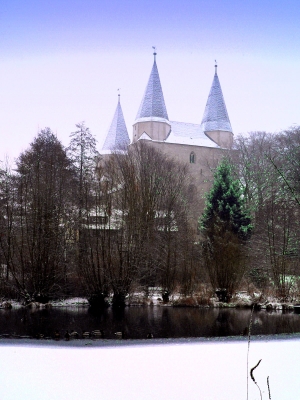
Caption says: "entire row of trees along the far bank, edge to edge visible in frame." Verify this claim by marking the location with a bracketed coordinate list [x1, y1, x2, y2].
[0, 123, 300, 308]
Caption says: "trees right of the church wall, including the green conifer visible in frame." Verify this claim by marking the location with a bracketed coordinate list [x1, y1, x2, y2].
[200, 127, 300, 301]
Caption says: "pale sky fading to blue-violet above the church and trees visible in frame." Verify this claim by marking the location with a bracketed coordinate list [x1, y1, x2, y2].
[0, 0, 300, 160]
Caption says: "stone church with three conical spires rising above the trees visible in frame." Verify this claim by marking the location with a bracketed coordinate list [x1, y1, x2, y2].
[100, 53, 233, 231]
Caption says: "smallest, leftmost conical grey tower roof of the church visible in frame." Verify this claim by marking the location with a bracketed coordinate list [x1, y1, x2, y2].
[102, 95, 130, 150]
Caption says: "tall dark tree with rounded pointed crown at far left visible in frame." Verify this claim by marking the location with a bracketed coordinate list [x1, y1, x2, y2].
[4, 128, 73, 302]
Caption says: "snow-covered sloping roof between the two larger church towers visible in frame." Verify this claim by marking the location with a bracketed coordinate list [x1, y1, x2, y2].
[165, 121, 219, 148]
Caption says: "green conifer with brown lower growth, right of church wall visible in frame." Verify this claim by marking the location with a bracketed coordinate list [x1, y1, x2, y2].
[200, 159, 252, 300]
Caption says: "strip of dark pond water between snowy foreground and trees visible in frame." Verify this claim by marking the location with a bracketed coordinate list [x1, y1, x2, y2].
[0, 307, 300, 339]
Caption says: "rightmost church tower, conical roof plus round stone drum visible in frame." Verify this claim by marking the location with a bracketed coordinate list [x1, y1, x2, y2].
[201, 65, 233, 149]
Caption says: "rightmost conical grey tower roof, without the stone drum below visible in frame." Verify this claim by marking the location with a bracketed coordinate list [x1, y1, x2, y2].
[201, 65, 232, 132]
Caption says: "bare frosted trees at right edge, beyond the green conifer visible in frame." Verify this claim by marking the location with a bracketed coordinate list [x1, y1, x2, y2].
[236, 131, 299, 298]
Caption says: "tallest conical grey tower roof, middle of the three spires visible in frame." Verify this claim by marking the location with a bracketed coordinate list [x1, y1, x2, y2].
[136, 53, 169, 120]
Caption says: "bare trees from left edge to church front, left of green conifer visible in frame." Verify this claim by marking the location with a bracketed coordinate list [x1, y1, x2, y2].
[0, 123, 202, 308]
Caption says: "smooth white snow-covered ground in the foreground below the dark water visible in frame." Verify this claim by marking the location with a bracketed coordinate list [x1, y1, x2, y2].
[0, 339, 300, 400]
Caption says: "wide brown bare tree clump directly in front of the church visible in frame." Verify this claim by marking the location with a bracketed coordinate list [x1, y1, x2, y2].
[99, 143, 192, 304]
